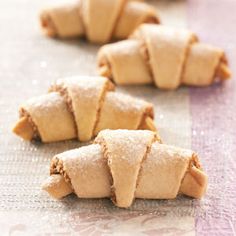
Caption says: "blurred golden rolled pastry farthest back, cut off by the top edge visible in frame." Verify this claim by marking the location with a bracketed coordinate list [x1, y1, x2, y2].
[40, 0, 159, 43]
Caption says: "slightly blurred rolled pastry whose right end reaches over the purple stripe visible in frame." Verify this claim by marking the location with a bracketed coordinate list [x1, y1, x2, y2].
[98, 24, 231, 89]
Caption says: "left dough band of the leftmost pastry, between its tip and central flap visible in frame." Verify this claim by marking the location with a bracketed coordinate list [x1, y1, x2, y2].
[22, 92, 77, 142]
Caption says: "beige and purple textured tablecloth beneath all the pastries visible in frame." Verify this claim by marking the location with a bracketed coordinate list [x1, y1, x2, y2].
[0, 0, 236, 235]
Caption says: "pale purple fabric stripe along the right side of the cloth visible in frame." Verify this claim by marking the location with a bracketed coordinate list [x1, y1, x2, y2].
[188, 0, 236, 235]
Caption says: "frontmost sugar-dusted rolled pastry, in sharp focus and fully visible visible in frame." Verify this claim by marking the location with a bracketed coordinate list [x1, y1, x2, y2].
[42, 130, 207, 207]
